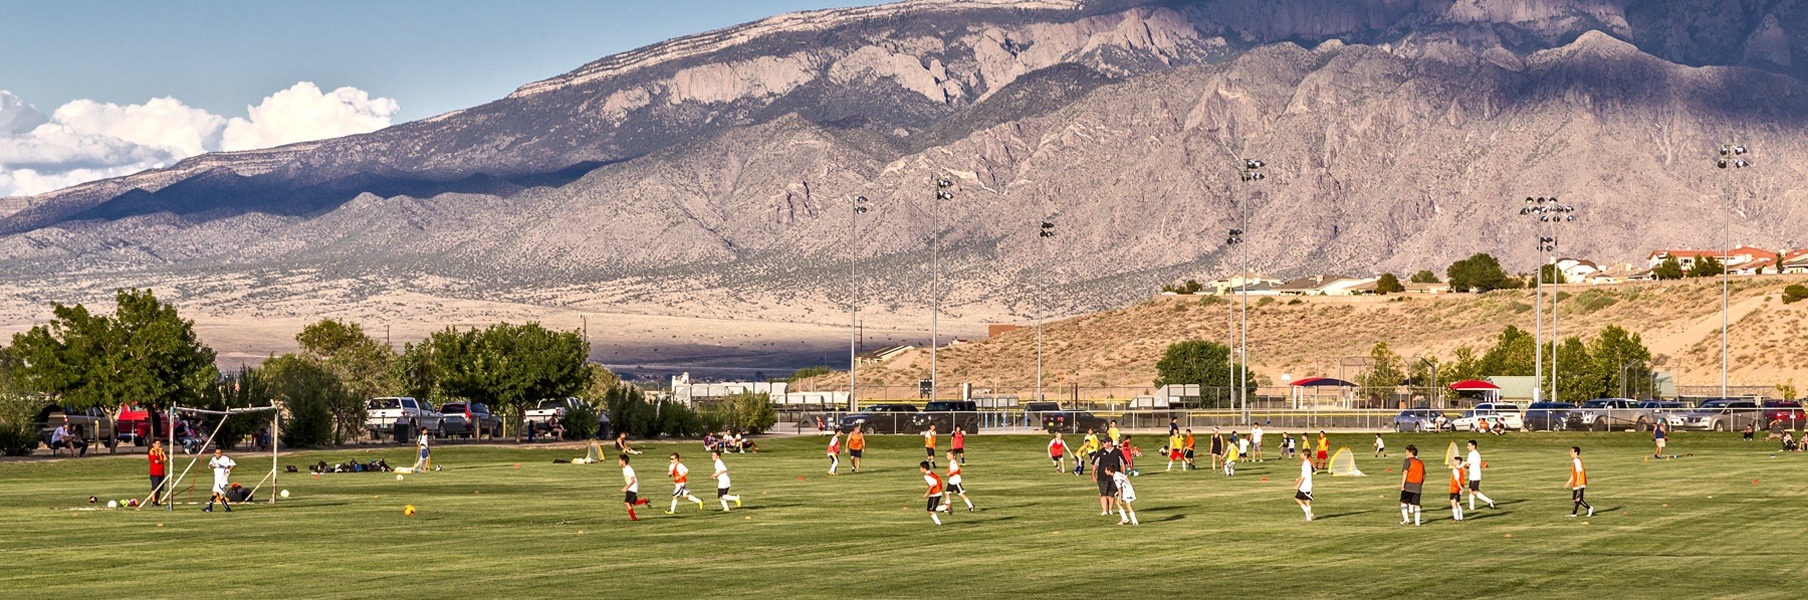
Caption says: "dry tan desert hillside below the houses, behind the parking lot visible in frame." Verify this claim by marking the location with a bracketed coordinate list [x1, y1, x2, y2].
[814, 277, 1808, 398]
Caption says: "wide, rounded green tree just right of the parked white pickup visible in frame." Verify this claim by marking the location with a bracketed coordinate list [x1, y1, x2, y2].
[425, 323, 589, 439]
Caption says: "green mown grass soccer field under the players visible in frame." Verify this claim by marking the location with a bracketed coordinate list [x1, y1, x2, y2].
[0, 428, 1808, 598]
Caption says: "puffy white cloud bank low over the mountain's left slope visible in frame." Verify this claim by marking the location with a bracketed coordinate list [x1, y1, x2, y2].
[0, 81, 398, 197]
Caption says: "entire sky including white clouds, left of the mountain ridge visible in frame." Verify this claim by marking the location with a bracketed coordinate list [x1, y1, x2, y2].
[0, 0, 873, 197]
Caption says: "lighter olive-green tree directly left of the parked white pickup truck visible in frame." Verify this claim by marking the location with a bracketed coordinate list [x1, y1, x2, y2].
[295, 318, 398, 443]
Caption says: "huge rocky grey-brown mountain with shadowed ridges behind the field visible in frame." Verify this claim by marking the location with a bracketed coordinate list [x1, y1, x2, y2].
[0, 0, 1808, 323]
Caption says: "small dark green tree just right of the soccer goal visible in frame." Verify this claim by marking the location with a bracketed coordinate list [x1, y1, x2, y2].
[260, 354, 343, 448]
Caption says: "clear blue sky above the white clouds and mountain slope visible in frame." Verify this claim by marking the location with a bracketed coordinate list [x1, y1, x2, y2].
[0, 0, 879, 123]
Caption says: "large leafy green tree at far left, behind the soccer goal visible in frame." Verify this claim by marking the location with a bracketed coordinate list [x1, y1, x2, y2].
[13, 289, 219, 433]
